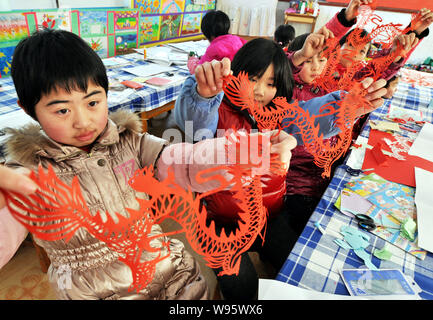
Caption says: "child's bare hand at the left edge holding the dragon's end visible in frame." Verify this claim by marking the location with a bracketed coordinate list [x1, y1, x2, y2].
[0, 166, 38, 209]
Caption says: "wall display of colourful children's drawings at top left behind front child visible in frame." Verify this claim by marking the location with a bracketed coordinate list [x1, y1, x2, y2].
[0, 0, 215, 77]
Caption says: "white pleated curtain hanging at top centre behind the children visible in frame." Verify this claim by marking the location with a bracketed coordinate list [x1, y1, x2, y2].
[216, 0, 278, 37]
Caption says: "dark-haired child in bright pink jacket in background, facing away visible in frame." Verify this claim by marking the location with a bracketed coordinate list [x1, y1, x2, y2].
[188, 10, 247, 74]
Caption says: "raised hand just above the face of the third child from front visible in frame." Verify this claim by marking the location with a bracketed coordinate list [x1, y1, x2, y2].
[292, 27, 334, 67]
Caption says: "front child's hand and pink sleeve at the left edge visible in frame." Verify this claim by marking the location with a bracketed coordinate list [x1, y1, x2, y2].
[0, 166, 38, 269]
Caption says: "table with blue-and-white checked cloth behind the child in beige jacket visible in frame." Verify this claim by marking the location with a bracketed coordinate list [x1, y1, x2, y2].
[0, 53, 189, 160]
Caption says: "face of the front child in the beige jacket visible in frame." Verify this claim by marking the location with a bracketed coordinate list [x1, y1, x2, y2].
[35, 82, 108, 147]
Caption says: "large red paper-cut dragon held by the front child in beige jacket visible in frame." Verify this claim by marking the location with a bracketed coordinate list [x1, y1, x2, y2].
[6, 132, 285, 291]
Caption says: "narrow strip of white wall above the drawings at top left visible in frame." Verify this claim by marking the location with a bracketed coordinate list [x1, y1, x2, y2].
[0, 0, 131, 11]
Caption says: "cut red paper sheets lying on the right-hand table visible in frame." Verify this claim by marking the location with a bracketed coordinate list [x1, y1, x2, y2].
[362, 130, 433, 187]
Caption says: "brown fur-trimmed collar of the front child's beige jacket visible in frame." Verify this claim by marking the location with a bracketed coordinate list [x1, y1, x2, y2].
[5, 110, 142, 166]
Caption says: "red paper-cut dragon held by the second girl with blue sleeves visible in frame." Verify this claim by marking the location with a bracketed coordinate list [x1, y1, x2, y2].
[224, 72, 369, 177]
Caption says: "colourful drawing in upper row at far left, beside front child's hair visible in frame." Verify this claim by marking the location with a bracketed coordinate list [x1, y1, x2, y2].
[0, 13, 28, 42]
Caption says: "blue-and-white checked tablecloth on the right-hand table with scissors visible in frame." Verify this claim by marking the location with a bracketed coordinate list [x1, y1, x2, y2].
[276, 69, 433, 300]
